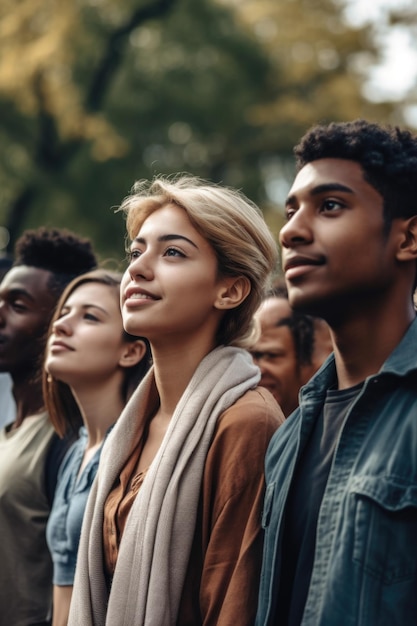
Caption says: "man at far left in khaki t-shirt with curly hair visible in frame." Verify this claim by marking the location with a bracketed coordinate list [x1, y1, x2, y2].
[0, 228, 96, 626]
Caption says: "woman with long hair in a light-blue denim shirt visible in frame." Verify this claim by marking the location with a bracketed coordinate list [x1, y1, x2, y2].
[44, 270, 150, 626]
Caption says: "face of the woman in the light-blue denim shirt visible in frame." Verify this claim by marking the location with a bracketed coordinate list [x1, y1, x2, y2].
[46, 282, 126, 389]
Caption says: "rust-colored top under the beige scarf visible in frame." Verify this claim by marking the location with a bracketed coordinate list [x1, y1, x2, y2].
[103, 387, 284, 626]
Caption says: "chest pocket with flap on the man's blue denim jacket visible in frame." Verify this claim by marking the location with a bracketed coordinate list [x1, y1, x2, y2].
[351, 476, 417, 585]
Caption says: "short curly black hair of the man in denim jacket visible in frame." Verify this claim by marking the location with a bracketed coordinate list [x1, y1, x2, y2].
[294, 119, 417, 230]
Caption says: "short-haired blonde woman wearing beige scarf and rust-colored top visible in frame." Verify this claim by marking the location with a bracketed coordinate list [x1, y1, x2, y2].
[69, 177, 284, 626]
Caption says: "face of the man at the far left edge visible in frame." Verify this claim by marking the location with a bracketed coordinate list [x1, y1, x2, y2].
[0, 265, 56, 381]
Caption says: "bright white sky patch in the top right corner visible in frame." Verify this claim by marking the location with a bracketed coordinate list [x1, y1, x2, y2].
[346, 0, 417, 100]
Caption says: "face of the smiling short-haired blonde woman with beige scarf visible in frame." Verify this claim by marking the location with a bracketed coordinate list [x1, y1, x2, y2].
[121, 205, 224, 345]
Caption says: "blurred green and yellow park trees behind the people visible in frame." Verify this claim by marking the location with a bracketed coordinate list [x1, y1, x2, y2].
[0, 0, 417, 263]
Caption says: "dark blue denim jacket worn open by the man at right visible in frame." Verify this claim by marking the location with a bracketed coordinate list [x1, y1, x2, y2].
[256, 320, 417, 626]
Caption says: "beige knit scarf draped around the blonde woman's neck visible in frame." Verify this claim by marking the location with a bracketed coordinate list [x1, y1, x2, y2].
[68, 347, 259, 626]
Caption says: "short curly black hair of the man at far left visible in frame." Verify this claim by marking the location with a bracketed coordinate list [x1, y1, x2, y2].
[13, 226, 97, 299]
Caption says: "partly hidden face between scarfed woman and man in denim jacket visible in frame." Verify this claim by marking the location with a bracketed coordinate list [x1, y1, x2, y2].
[251, 297, 307, 417]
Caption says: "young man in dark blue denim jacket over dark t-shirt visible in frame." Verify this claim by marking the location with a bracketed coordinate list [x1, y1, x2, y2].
[256, 120, 417, 626]
